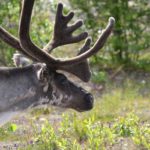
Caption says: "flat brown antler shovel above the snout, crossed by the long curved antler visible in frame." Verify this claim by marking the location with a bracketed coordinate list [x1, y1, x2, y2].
[58, 38, 91, 82]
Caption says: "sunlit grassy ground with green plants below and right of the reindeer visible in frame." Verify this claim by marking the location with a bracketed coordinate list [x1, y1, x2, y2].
[0, 74, 150, 150]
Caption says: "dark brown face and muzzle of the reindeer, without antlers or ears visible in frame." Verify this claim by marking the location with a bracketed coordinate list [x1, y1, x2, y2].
[50, 73, 93, 111]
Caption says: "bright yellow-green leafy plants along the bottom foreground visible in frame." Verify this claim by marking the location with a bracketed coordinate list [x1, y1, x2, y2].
[30, 113, 150, 150]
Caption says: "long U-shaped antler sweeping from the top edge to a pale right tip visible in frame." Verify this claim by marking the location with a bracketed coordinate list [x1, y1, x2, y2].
[19, 0, 115, 68]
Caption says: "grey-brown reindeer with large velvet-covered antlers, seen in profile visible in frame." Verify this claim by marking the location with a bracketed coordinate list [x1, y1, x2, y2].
[0, 0, 115, 124]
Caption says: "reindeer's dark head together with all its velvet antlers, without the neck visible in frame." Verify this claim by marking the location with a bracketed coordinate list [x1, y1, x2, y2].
[0, 0, 115, 111]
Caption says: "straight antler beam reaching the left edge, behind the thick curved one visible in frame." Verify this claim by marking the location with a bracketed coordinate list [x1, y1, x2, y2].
[0, 27, 36, 60]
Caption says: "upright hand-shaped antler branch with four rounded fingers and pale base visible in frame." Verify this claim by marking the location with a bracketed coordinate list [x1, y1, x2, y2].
[44, 3, 88, 52]
